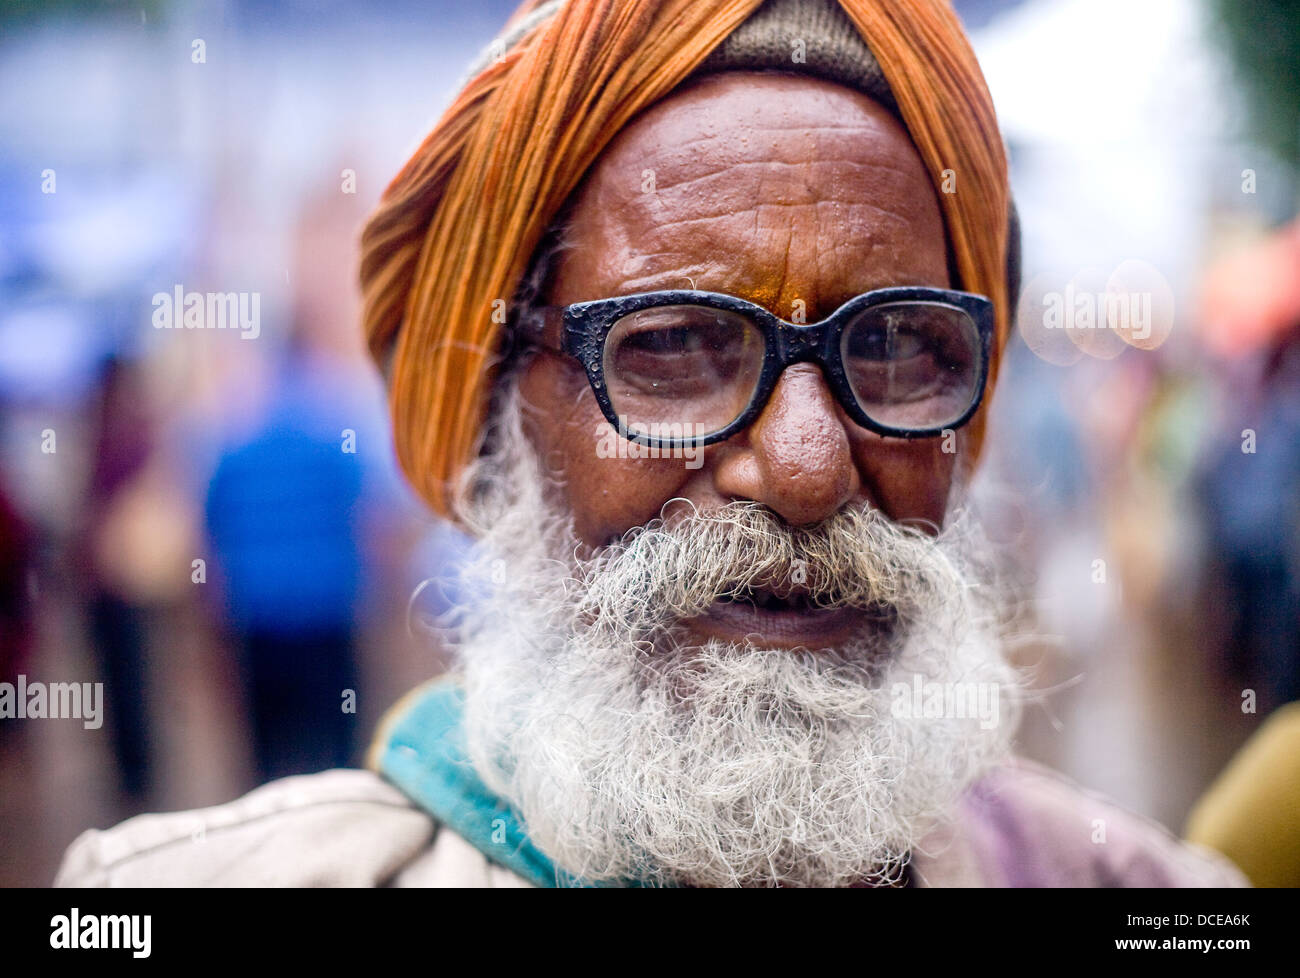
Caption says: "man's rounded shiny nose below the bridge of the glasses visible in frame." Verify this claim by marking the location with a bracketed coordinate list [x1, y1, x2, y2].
[714, 363, 862, 525]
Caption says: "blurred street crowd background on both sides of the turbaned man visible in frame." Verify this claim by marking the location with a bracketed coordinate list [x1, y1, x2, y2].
[0, 0, 1300, 886]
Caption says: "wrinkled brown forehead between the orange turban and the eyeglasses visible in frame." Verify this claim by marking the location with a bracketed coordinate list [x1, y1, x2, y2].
[551, 72, 949, 325]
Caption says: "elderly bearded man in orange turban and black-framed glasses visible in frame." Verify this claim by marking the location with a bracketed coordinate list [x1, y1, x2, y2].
[60, 0, 1240, 886]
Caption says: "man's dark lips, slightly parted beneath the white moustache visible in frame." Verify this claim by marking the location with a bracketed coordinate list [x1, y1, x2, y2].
[684, 589, 885, 649]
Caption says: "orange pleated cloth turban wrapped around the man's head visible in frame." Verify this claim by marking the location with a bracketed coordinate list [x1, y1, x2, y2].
[361, 0, 1014, 515]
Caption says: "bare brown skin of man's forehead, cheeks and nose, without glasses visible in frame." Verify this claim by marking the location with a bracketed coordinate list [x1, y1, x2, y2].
[520, 72, 961, 644]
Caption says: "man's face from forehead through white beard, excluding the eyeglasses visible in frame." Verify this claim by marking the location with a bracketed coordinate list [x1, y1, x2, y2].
[460, 73, 1015, 886]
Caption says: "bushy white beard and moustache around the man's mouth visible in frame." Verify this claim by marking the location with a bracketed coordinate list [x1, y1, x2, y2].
[449, 387, 1018, 887]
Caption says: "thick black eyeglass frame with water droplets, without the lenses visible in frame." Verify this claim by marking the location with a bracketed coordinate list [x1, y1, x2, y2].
[515, 286, 993, 450]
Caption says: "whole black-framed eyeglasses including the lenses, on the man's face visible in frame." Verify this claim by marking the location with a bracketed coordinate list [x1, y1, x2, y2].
[516, 286, 993, 449]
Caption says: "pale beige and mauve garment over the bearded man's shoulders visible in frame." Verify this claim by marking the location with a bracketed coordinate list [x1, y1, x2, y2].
[55, 761, 1247, 887]
